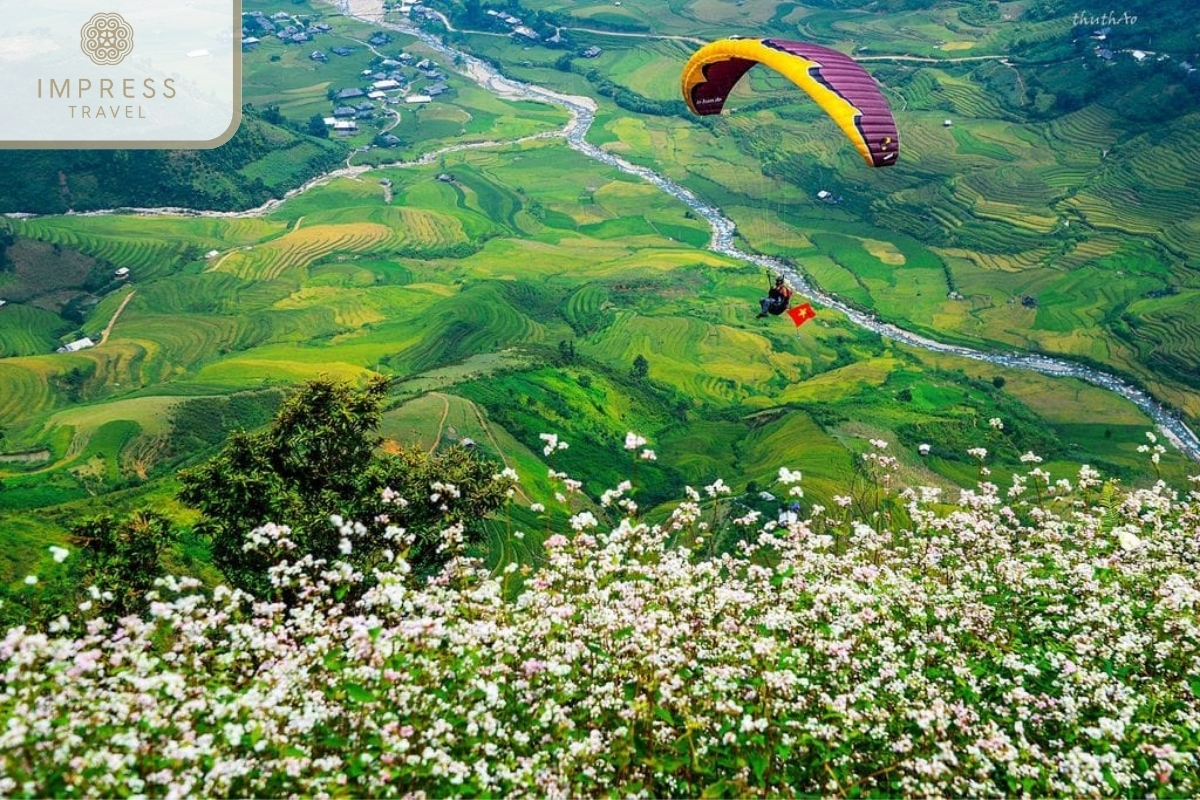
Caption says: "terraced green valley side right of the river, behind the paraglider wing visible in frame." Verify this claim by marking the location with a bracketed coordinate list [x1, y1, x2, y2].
[451, 0, 1200, 423]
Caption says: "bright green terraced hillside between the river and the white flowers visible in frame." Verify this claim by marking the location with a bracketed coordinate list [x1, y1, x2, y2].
[0, 140, 1186, 576]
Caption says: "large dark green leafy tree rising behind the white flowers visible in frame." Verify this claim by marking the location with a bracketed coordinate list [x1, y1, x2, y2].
[180, 378, 511, 596]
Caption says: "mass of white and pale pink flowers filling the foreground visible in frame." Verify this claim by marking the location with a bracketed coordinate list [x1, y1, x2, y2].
[0, 439, 1200, 796]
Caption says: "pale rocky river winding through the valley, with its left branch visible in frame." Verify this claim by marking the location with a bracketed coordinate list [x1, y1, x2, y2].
[10, 0, 1200, 462]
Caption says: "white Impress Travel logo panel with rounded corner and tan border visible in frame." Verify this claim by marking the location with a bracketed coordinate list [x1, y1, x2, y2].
[0, 0, 241, 149]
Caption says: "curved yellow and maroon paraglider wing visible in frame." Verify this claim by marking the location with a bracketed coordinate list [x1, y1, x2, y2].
[683, 38, 900, 167]
